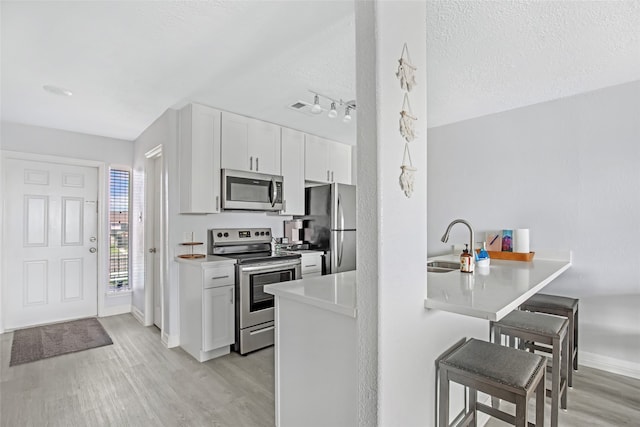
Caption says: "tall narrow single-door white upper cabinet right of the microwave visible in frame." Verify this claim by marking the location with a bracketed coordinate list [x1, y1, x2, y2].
[280, 128, 305, 215]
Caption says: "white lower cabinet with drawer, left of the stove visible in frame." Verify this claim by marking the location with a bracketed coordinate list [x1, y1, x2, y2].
[180, 260, 235, 362]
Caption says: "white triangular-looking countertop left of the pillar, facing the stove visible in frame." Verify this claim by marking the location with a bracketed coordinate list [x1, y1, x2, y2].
[264, 271, 357, 318]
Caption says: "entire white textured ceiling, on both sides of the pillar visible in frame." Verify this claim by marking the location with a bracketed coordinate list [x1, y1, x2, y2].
[0, 0, 640, 143]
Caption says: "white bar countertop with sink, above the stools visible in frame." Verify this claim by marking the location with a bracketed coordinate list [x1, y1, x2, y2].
[424, 251, 571, 321]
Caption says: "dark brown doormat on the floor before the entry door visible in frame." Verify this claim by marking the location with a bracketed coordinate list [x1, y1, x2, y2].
[9, 317, 113, 366]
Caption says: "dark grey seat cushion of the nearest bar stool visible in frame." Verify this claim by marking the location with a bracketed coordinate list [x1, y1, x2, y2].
[440, 339, 546, 389]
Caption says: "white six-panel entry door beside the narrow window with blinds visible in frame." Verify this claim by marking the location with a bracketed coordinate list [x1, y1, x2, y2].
[3, 159, 98, 329]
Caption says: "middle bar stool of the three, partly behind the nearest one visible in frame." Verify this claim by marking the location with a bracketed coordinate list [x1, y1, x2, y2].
[489, 310, 569, 427]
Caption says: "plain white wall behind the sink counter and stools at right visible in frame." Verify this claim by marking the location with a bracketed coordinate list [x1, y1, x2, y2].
[427, 81, 640, 376]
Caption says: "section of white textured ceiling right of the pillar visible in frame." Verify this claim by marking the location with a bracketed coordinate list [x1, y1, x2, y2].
[427, 1, 640, 127]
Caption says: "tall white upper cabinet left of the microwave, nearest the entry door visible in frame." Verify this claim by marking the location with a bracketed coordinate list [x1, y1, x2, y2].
[178, 104, 220, 214]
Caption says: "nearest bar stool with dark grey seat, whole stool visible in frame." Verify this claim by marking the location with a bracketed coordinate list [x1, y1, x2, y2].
[438, 339, 547, 427]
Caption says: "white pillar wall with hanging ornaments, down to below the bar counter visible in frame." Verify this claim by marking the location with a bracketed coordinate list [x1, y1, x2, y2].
[356, 1, 488, 427]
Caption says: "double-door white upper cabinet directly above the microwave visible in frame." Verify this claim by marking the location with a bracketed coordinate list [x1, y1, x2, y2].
[221, 112, 280, 175]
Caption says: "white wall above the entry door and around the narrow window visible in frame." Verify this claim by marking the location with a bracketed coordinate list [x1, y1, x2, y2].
[0, 122, 133, 315]
